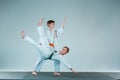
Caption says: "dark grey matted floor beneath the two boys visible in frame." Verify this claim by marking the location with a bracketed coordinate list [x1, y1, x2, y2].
[0, 72, 120, 80]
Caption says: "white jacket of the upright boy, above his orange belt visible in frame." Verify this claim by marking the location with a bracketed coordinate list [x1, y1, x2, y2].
[37, 26, 63, 47]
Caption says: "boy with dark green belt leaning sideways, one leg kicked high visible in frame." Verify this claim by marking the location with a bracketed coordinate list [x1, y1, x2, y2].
[21, 31, 76, 75]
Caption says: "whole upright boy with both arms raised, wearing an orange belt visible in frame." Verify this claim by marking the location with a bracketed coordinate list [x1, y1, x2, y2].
[36, 17, 66, 76]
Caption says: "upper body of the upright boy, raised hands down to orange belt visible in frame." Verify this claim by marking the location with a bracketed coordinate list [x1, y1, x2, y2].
[37, 17, 66, 50]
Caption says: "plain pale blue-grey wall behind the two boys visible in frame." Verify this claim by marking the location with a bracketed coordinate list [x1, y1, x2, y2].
[0, 0, 120, 72]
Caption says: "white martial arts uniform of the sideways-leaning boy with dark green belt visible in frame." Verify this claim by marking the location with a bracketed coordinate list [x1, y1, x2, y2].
[24, 36, 72, 72]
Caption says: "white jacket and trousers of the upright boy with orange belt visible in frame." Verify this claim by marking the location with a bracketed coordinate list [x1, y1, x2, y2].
[37, 26, 63, 72]
